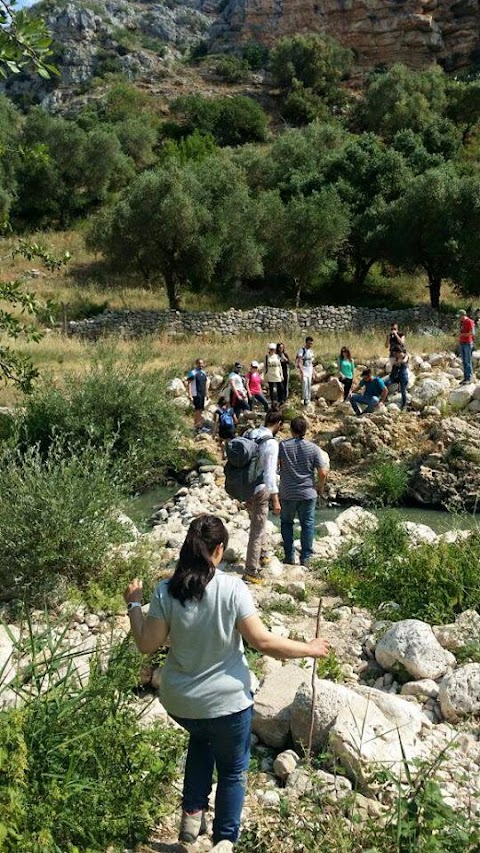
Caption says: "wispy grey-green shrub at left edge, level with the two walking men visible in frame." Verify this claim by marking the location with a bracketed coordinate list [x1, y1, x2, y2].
[0, 444, 128, 602]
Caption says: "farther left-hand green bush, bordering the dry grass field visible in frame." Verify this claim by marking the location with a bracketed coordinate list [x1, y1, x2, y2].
[19, 349, 186, 491]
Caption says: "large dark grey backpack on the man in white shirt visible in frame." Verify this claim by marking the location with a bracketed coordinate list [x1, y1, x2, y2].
[225, 430, 273, 501]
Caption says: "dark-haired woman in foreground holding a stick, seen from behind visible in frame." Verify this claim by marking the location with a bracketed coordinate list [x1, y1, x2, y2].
[125, 515, 328, 853]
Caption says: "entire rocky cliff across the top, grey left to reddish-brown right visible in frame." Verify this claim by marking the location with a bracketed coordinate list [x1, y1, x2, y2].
[2, 0, 480, 111]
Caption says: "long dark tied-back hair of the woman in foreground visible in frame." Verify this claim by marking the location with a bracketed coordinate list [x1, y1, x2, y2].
[168, 515, 228, 604]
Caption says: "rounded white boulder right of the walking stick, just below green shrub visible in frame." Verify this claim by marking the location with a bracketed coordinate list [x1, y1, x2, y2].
[375, 619, 455, 679]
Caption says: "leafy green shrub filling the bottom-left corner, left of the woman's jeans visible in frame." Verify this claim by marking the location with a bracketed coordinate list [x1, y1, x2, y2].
[0, 626, 184, 853]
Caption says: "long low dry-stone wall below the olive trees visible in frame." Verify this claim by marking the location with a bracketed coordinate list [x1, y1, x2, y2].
[68, 305, 455, 340]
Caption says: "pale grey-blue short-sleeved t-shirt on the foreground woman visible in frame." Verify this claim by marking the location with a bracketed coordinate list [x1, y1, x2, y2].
[149, 569, 256, 720]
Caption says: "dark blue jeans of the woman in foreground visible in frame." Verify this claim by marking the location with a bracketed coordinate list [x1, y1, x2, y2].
[173, 705, 253, 844]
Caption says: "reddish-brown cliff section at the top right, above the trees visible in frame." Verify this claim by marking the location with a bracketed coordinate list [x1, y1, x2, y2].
[215, 0, 480, 71]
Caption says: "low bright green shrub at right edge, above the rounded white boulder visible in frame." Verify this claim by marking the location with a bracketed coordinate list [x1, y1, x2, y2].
[328, 513, 480, 623]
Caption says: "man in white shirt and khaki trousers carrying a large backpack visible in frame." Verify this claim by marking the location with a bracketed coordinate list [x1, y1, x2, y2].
[225, 411, 283, 583]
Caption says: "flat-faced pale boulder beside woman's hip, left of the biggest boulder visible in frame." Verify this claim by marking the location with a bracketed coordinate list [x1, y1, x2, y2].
[253, 664, 309, 749]
